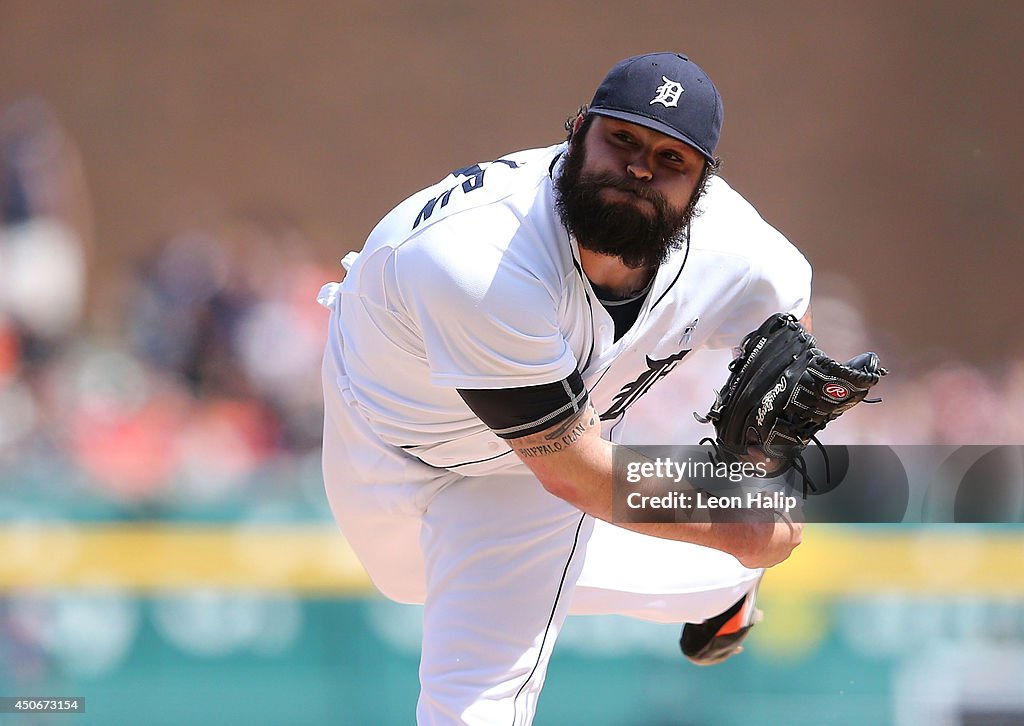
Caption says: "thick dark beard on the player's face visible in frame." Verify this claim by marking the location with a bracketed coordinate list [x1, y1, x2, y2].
[555, 125, 703, 269]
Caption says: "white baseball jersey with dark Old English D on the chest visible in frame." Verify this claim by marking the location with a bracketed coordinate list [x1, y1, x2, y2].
[322, 143, 810, 475]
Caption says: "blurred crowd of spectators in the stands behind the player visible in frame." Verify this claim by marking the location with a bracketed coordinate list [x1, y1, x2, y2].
[0, 98, 1024, 518]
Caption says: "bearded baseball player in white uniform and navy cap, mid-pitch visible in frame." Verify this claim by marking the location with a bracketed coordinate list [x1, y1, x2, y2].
[319, 53, 881, 724]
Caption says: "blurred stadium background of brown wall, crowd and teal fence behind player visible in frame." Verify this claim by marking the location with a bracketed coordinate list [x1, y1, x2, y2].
[0, 0, 1024, 726]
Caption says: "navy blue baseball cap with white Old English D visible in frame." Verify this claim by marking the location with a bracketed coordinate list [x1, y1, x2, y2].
[590, 53, 723, 162]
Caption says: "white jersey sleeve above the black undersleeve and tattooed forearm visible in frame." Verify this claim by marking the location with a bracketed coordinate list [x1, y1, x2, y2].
[394, 225, 577, 389]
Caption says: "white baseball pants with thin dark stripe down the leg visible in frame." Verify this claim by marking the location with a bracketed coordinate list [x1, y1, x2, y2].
[324, 354, 762, 726]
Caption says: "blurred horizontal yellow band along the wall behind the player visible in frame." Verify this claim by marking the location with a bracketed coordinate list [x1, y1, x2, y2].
[0, 522, 1024, 598]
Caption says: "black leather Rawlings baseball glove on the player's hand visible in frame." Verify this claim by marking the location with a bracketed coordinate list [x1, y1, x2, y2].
[694, 313, 888, 496]
